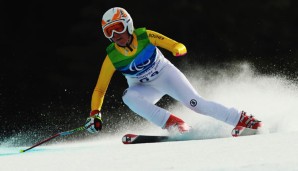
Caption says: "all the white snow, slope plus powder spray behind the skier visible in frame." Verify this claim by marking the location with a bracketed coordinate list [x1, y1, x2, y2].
[0, 64, 298, 171]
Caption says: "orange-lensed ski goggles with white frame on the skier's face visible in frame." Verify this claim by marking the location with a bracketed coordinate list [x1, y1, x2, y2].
[103, 21, 127, 39]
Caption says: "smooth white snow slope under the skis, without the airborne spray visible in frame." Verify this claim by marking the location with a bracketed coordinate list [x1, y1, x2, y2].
[0, 132, 298, 171]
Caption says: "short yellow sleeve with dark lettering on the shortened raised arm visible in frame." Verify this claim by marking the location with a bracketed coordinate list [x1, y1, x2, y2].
[147, 30, 187, 56]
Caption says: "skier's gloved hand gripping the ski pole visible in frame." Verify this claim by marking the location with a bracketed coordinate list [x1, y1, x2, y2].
[85, 110, 102, 133]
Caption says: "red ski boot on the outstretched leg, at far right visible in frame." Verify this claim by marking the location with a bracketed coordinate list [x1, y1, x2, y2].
[232, 111, 262, 137]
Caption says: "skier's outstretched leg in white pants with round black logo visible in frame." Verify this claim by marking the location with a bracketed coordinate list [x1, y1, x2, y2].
[159, 65, 240, 126]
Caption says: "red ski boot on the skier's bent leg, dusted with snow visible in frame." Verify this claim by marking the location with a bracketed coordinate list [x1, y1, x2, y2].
[164, 114, 190, 134]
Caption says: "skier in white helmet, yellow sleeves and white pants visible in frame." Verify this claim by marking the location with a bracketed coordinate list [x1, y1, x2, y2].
[85, 7, 261, 136]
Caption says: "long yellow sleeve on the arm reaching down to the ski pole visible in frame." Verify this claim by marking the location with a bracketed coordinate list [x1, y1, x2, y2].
[91, 56, 116, 111]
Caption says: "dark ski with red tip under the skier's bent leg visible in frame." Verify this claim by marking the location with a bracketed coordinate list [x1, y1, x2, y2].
[122, 134, 173, 144]
